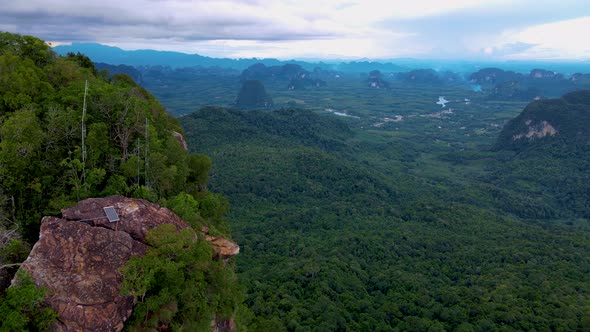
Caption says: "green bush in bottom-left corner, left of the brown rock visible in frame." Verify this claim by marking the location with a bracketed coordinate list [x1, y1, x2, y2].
[0, 270, 57, 331]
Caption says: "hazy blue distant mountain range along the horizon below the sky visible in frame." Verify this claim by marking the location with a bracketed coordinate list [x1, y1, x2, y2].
[53, 43, 590, 75]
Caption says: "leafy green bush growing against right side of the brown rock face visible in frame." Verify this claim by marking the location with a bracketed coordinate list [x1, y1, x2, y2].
[122, 224, 240, 331]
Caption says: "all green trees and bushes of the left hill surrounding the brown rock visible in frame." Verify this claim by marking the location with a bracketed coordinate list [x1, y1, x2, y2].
[0, 32, 240, 331]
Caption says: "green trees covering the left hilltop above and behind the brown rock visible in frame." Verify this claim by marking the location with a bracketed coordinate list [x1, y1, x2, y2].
[0, 33, 217, 242]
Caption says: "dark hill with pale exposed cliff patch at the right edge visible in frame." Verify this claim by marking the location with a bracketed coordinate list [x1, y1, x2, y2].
[496, 90, 590, 149]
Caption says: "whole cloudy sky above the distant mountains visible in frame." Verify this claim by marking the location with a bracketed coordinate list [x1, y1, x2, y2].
[0, 0, 590, 60]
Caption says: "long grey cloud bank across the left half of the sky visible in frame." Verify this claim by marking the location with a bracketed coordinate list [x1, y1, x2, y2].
[0, 0, 338, 41]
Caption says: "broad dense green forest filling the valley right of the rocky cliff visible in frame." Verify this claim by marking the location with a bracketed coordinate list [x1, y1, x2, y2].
[181, 105, 590, 331]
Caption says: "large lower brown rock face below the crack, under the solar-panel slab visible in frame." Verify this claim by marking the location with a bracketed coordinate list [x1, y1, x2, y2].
[21, 217, 147, 331]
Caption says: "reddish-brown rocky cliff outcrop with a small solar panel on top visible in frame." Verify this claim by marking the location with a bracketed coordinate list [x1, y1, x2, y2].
[21, 196, 239, 331]
